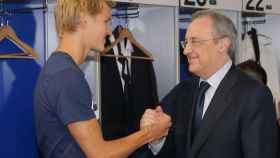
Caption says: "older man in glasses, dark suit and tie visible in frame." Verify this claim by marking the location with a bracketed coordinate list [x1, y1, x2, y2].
[142, 10, 277, 158]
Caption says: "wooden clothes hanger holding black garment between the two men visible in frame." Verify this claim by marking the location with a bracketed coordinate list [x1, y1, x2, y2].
[102, 27, 154, 61]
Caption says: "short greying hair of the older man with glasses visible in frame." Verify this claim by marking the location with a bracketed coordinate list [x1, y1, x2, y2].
[192, 9, 237, 59]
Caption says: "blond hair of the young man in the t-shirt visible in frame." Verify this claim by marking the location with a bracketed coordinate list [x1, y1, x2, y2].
[54, 0, 110, 36]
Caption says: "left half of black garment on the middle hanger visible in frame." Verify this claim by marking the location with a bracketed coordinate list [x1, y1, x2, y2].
[101, 49, 126, 140]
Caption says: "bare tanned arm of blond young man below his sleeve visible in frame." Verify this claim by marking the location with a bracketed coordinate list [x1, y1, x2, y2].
[69, 120, 155, 158]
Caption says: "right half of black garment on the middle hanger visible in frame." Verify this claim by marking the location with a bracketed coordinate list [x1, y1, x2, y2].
[127, 44, 158, 133]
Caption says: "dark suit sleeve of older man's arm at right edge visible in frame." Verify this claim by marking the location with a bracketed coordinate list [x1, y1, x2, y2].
[241, 87, 278, 158]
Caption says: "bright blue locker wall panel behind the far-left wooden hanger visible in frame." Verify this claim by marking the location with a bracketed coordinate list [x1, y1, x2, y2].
[0, 4, 45, 158]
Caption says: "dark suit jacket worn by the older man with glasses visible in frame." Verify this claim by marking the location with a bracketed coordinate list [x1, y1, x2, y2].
[157, 67, 277, 158]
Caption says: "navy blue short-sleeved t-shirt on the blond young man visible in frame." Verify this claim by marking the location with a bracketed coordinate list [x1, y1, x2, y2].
[34, 52, 95, 158]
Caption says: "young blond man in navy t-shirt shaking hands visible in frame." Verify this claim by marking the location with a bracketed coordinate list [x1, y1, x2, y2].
[34, 0, 171, 158]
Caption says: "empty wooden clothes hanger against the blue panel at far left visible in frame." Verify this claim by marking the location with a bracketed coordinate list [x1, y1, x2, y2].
[0, 25, 39, 59]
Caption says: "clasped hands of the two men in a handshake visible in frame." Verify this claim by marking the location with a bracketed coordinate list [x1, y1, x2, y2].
[140, 106, 172, 143]
